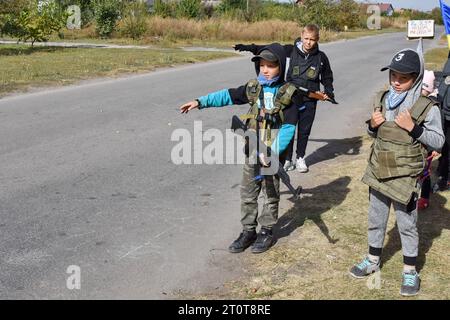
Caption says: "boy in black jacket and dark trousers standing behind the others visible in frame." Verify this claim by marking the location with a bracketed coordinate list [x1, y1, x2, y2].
[234, 24, 334, 172]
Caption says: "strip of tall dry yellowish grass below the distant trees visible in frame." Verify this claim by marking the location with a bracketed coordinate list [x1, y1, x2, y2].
[26, 22, 406, 48]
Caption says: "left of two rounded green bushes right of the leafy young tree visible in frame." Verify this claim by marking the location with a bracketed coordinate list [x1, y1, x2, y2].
[93, 0, 121, 38]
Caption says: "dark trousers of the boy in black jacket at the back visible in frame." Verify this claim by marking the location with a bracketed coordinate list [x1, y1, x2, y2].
[286, 101, 317, 160]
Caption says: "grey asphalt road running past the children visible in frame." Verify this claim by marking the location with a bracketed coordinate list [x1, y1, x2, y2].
[0, 29, 437, 299]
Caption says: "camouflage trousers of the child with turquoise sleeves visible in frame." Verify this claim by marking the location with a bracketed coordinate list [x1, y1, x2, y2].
[241, 163, 280, 230]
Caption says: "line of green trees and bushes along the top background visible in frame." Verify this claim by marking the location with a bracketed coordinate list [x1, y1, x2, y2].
[0, 0, 442, 43]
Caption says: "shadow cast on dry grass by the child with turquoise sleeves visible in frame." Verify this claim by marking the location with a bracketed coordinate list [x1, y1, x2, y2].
[274, 176, 351, 243]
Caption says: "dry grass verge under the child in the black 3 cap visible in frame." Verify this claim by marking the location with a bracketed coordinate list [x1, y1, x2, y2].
[195, 138, 450, 300]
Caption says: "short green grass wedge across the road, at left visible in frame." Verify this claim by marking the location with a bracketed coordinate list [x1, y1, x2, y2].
[0, 45, 233, 96]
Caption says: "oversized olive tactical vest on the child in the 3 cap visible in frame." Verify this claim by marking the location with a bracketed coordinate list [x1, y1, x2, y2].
[362, 91, 435, 205]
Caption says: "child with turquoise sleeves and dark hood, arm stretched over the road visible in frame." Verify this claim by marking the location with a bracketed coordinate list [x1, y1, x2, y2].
[180, 43, 298, 253]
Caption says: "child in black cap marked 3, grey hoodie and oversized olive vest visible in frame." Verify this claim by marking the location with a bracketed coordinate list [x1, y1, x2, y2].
[350, 49, 444, 296]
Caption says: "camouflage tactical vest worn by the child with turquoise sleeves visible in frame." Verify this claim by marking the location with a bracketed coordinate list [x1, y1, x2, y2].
[240, 79, 297, 147]
